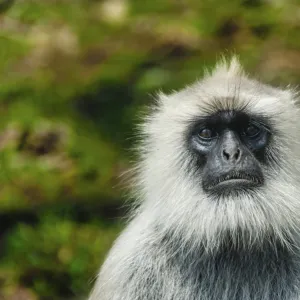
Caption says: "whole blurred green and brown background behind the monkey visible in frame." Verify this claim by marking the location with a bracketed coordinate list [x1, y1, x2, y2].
[0, 0, 300, 300]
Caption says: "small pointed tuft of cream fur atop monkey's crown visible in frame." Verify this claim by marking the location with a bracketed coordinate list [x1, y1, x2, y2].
[211, 55, 244, 77]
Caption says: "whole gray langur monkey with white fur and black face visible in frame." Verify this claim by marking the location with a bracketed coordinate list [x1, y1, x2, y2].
[89, 58, 300, 300]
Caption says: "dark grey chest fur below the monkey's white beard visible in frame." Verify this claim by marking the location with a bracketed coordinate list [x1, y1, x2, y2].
[163, 233, 300, 300]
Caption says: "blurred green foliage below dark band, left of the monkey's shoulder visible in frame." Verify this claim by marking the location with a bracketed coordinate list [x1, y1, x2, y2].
[0, 216, 122, 299]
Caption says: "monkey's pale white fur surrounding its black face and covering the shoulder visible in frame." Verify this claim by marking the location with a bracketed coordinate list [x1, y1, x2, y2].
[90, 58, 300, 300]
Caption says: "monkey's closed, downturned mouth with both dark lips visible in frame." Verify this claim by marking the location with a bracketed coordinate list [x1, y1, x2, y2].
[203, 172, 263, 193]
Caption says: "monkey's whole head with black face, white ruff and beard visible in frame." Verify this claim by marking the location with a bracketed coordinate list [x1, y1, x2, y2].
[139, 58, 300, 250]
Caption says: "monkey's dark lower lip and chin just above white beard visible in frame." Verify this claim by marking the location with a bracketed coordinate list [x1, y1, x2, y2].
[207, 178, 261, 197]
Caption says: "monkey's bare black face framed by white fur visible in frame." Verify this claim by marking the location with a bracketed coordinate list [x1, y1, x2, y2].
[189, 111, 271, 196]
